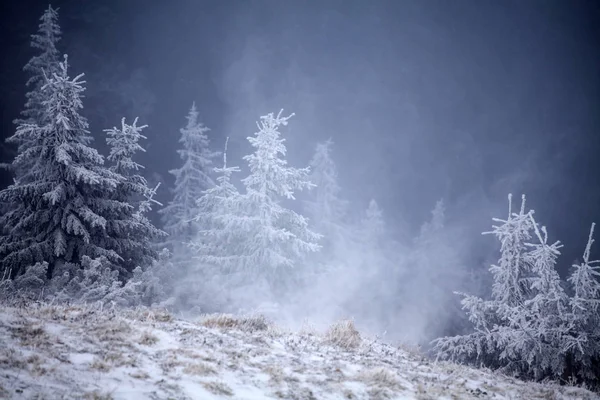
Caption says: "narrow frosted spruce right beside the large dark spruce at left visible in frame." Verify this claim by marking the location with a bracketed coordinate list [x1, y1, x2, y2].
[105, 118, 166, 272]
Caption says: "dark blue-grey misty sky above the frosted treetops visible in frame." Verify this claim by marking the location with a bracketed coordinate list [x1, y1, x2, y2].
[0, 0, 600, 272]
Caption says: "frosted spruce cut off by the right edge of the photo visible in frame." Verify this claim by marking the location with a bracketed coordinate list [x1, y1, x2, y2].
[564, 224, 600, 387]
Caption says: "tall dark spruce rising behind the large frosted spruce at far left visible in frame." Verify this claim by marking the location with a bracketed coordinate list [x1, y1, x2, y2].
[8, 5, 61, 179]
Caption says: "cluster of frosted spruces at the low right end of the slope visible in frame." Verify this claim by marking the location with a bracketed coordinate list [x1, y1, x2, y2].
[434, 197, 600, 385]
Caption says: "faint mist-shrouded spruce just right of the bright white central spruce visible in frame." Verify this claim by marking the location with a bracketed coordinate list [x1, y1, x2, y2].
[306, 139, 348, 241]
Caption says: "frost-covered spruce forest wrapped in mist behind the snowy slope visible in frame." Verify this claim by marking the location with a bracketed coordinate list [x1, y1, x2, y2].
[0, 7, 600, 390]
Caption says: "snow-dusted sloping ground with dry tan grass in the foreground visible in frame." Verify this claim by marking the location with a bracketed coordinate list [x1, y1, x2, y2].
[0, 305, 598, 400]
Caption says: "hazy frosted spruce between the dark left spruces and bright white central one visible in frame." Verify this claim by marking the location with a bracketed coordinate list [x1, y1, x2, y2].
[159, 103, 219, 256]
